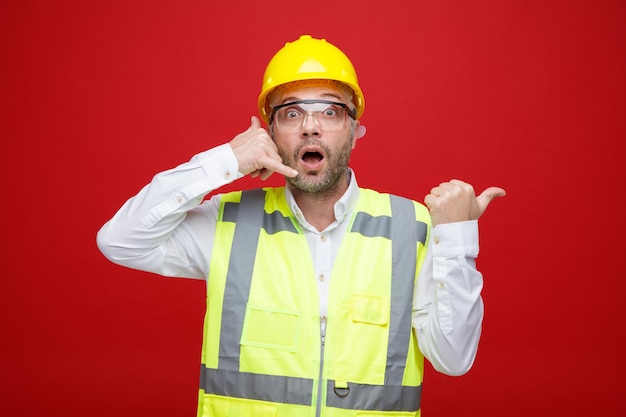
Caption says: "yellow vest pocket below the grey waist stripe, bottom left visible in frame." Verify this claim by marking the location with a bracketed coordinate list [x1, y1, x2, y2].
[202, 394, 278, 417]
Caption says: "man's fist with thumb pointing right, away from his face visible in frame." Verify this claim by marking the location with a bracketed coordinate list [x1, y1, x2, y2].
[424, 180, 506, 227]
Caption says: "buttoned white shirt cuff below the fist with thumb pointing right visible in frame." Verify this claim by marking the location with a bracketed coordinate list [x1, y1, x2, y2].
[431, 220, 479, 258]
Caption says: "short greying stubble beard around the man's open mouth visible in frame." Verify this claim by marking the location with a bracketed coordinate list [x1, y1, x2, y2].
[278, 139, 352, 195]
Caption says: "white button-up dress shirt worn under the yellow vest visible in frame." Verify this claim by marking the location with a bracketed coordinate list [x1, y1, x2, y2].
[97, 144, 483, 375]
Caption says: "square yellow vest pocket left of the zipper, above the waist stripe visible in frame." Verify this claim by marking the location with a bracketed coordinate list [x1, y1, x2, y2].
[241, 304, 302, 352]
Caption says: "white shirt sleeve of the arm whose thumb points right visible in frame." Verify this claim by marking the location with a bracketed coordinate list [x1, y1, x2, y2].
[413, 220, 484, 375]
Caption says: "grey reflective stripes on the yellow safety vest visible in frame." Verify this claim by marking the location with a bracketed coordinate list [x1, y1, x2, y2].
[200, 189, 427, 411]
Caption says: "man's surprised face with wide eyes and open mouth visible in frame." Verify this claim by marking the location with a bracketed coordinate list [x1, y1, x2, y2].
[272, 85, 358, 193]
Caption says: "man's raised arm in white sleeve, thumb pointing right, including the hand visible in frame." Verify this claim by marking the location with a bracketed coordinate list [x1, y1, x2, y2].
[413, 180, 506, 375]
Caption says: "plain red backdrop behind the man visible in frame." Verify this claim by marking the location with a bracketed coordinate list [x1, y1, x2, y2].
[0, 0, 626, 417]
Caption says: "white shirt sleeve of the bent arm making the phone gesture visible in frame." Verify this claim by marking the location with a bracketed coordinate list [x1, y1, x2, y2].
[97, 144, 242, 279]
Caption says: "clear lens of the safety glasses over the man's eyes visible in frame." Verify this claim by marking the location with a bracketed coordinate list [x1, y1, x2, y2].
[274, 100, 347, 132]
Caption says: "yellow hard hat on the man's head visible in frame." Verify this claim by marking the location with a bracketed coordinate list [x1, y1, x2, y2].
[259, 35, 365, 123]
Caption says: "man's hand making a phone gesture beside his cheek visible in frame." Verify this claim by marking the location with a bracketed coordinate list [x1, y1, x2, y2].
[230, 116, 298, 180]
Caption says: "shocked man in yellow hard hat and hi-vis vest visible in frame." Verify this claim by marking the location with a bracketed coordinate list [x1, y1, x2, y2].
[98, 36, 504, 416]
